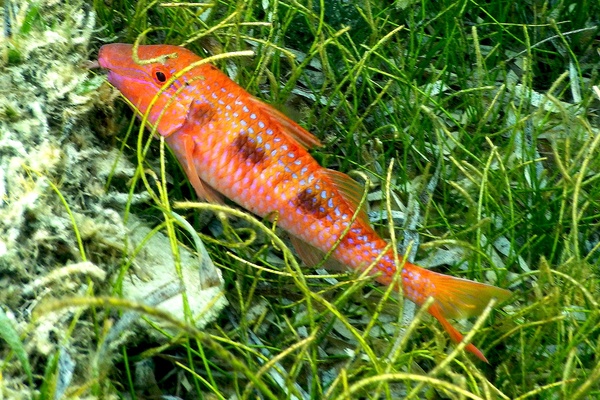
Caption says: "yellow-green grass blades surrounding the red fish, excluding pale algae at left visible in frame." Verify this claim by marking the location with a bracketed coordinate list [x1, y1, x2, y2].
[2, 0, 600, 399]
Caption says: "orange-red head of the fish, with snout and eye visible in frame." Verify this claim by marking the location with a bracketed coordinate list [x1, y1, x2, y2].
[98, 43, 202, 137]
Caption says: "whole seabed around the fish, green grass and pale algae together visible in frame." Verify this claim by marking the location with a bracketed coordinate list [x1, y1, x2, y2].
[0, 0, 600, 399]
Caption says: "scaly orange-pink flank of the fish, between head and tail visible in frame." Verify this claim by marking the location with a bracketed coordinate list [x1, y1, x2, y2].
[167, 95, 376, 265]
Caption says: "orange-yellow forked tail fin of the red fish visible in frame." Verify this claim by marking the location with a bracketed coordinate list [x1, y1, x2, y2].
[419, 269, 511, 363]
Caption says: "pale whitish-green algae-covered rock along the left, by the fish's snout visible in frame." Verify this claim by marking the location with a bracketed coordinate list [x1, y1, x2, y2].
[0, 0, 225, 398]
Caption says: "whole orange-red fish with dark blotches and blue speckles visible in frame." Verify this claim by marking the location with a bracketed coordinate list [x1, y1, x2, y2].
[97, 43, 511, 362]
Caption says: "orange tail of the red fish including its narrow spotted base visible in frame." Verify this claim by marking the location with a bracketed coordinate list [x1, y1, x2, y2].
[403, 264, 511, 362]
